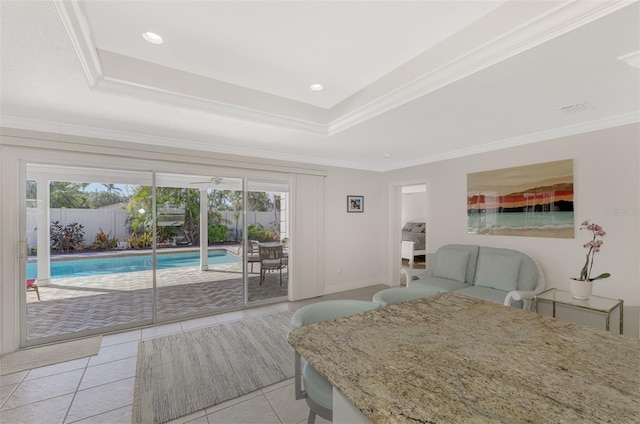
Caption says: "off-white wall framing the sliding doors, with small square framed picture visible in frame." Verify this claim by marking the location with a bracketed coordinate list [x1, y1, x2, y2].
[0, 129, 388, 353]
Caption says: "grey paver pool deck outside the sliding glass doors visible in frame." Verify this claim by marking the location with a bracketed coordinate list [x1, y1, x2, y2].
[27, 245, 288, 340]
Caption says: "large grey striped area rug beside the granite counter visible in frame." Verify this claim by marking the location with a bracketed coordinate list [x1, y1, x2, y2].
[132, 312, 294, 424]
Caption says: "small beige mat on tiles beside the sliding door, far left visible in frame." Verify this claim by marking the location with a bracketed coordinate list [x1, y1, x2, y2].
[0, 336, 102, 375]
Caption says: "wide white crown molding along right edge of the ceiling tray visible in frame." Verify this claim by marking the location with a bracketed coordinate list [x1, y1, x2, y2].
[328, 0, 637, 135]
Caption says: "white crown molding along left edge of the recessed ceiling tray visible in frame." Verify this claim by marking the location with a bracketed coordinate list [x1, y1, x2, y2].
[51, 0, 104, 88]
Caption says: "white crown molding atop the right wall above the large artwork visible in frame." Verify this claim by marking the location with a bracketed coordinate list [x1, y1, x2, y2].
[378, 111, 640, 172]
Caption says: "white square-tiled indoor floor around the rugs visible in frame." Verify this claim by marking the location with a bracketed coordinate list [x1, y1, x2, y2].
[0, 285, 387, 424]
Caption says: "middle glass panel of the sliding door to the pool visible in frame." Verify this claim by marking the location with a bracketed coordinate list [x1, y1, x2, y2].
[156, 173, 245, 321]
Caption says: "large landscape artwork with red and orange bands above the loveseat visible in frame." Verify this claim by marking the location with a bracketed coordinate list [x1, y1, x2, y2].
[467, 159, 574, 238]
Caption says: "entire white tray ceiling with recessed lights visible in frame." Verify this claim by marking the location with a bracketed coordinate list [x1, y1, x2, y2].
[1, 0, 640, 170]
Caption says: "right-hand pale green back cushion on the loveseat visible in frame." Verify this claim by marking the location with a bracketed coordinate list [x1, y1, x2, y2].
[474, 250, 522, 292]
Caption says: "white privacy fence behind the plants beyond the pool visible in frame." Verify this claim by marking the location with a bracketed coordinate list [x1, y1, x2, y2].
[27, 208, 284, 247]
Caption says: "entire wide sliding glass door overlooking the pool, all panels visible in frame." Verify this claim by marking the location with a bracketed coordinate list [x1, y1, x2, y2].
[21, 164, 289, 345]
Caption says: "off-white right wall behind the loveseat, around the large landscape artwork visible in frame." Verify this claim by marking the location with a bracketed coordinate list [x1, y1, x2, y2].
[386, 124, 640, 335]
